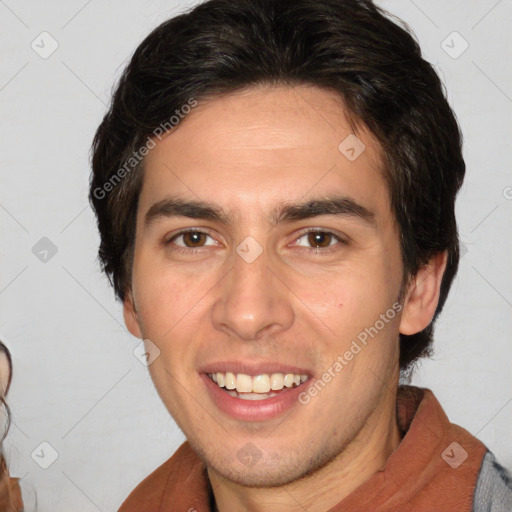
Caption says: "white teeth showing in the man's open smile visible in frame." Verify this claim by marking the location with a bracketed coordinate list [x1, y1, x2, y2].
[206, 372, 309, 400]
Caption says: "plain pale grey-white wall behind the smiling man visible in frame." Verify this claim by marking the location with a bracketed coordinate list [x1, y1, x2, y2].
[0, 0, 512, 512]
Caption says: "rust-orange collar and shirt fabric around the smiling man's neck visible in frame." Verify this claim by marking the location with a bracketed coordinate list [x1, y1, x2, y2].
[119, 386, 490, 512]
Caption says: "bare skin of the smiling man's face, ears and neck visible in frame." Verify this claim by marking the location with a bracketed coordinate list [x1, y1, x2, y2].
[124, 86, 445, 512]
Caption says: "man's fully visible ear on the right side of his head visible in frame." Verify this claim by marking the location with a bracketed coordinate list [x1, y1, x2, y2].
[400, 251, 448, 335]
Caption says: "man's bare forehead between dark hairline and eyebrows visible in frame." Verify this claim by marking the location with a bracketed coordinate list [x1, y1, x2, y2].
[139, 86, 388, 220]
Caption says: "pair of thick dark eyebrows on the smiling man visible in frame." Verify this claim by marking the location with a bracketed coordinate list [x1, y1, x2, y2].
[144, 196, 375, 227]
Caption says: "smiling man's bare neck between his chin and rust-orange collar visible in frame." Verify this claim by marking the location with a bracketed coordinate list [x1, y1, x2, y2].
[208, 385, 401, 512]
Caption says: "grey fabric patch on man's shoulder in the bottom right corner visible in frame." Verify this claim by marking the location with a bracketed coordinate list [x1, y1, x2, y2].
[473, 451, 512, 512]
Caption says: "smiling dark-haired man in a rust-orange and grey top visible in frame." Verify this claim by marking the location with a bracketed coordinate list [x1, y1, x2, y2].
[90, 0, 512, 512]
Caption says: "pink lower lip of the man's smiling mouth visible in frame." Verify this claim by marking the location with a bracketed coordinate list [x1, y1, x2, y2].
[200, 373, 312, 421]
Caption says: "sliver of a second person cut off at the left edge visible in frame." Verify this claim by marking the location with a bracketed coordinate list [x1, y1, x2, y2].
[0, 341, 23, 512]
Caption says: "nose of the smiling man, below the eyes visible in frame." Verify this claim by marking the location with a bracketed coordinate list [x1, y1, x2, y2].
[212, 243, 294, 341]
